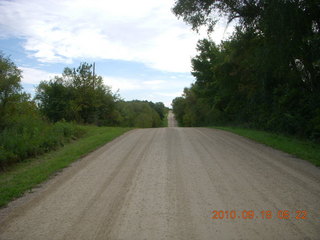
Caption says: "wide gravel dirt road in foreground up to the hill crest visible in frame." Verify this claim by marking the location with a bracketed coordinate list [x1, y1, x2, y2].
[0, 119, 320, 240]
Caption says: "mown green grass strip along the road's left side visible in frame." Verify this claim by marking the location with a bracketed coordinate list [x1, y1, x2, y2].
[0, 126, 131, 207]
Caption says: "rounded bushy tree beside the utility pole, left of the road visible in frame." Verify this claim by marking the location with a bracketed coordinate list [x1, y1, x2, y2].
[35, 63, 116, 125]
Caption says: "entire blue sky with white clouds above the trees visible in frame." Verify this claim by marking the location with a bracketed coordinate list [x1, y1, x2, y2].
[0, 0, 232, 107]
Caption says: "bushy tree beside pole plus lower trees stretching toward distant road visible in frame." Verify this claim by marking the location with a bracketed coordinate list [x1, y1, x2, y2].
[35, 63, 166, 127]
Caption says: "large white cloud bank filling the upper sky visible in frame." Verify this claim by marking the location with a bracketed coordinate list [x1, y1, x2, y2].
[0, 0, 234, 72]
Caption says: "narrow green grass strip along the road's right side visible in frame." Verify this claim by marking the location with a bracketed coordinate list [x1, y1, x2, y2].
[212, 127, 320, 167]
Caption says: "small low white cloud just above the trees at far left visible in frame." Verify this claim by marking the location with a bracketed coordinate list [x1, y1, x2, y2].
[19, 67, 59, 85]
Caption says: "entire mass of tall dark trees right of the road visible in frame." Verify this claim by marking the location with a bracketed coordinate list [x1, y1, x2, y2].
[173, 0, 320, 141]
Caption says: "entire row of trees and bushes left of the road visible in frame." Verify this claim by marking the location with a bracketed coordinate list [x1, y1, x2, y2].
[0, 53, 168, 169]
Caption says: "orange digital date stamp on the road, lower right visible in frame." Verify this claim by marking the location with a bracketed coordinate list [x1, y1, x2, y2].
[211, 210, 308, 219]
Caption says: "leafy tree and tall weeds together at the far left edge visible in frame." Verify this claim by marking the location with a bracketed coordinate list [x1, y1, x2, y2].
[0, 54, 85, 168]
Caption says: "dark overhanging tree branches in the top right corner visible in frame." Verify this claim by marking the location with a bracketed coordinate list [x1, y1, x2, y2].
[173, 0, 320, 92]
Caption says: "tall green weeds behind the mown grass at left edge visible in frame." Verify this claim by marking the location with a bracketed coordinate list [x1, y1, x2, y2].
[0, 114, 84, 170]
